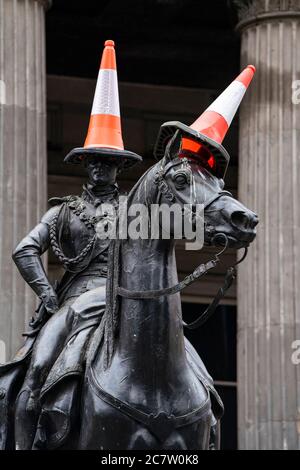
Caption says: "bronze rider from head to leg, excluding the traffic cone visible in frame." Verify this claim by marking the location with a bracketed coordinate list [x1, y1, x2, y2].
[0, 156, 118, 449]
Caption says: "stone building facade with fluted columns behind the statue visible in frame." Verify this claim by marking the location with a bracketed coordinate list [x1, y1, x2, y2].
[0, 0, 300, 449]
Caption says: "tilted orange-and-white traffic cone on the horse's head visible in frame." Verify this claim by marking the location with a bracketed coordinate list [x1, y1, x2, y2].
[155, 65, 255, 177]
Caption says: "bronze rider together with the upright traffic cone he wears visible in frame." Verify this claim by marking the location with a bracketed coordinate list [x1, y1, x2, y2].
[0, 41, 142, 450]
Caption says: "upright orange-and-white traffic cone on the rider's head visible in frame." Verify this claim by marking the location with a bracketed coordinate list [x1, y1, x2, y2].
[65, 40, 142, 167]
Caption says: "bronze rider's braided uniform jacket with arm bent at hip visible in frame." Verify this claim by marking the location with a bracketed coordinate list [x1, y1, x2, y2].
[13, 185, 118, 304]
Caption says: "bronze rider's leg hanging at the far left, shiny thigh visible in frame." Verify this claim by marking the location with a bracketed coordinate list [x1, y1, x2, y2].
[15, 301, 72, 450]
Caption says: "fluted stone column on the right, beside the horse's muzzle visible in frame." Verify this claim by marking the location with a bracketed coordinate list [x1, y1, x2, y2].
[234, 0, 300, 449]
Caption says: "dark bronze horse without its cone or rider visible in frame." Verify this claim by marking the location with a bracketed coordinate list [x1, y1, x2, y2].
[78, 133, 258, 450]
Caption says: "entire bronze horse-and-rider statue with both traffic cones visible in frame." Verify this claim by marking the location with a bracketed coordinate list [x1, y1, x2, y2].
[0, 41, 258, 450]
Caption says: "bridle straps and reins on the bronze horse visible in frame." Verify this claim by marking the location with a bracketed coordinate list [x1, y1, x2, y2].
[116, 159, 248, 330]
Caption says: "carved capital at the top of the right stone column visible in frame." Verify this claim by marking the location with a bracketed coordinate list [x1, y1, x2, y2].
[230, 0, 300, 31]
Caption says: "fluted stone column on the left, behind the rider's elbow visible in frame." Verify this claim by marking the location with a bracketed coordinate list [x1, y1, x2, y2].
[0, 0, 49, 362]
